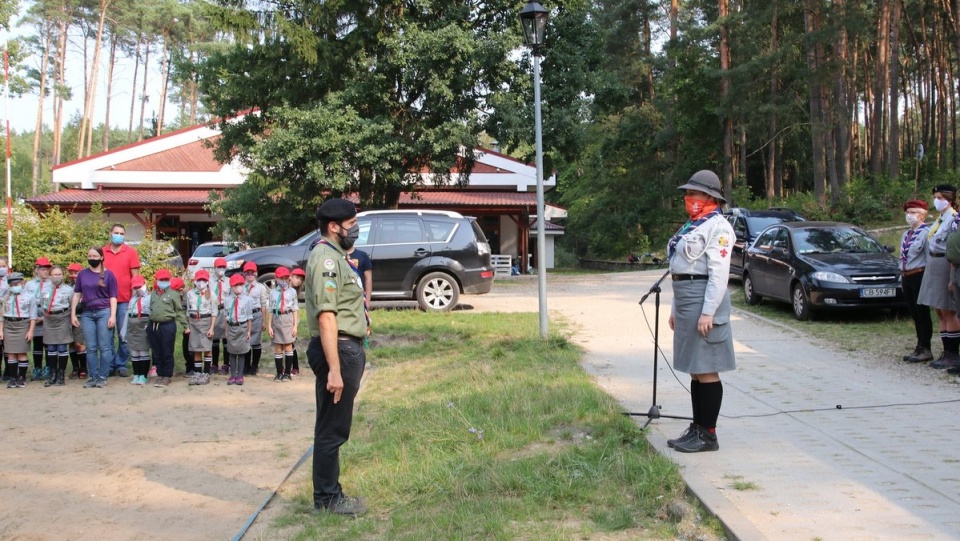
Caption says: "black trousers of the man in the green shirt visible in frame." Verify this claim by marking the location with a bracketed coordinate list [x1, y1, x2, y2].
[307, 337, 367, 507]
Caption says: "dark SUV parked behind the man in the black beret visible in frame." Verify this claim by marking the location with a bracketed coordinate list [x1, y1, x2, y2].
[227, 210, 494, 312]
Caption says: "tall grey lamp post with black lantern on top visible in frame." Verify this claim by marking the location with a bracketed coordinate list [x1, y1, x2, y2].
[520, 0, 550, 338]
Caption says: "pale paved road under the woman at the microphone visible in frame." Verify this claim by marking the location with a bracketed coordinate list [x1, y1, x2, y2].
[462, 271, 960, 540]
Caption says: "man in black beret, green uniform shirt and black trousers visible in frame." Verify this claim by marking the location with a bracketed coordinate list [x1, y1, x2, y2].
[304, 199, 367, 515]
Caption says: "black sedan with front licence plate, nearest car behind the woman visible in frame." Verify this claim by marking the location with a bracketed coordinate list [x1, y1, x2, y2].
[743, 222, 904, 320]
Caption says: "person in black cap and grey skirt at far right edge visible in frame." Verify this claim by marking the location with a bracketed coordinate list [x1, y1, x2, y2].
[917, 184, 960, 368]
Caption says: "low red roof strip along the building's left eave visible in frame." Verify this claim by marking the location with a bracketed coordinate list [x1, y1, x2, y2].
[27, 188, 211, 205]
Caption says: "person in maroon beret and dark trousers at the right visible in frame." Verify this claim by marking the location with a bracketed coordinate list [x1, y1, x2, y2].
[900, 199, 933, 363]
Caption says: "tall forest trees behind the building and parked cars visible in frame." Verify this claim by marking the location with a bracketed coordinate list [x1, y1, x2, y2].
[0, 0, 960, 257]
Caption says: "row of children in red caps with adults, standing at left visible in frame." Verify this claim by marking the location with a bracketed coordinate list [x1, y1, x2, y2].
[0, 249, 326, 388]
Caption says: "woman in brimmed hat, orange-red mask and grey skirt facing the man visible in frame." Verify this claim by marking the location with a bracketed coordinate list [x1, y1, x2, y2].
[667, 170, 736, 453]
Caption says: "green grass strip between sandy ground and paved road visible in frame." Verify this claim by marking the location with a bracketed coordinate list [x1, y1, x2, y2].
[267, 310, 720, 540]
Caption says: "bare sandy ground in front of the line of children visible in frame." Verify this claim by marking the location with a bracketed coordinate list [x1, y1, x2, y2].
[0, 355, 315, 541]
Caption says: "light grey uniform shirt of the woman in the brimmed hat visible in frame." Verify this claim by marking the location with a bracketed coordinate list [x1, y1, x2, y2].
[670, 214, 735, 316]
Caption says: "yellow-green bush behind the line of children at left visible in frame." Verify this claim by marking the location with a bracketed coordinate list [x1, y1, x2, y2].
[0, 204, 176, 282]
